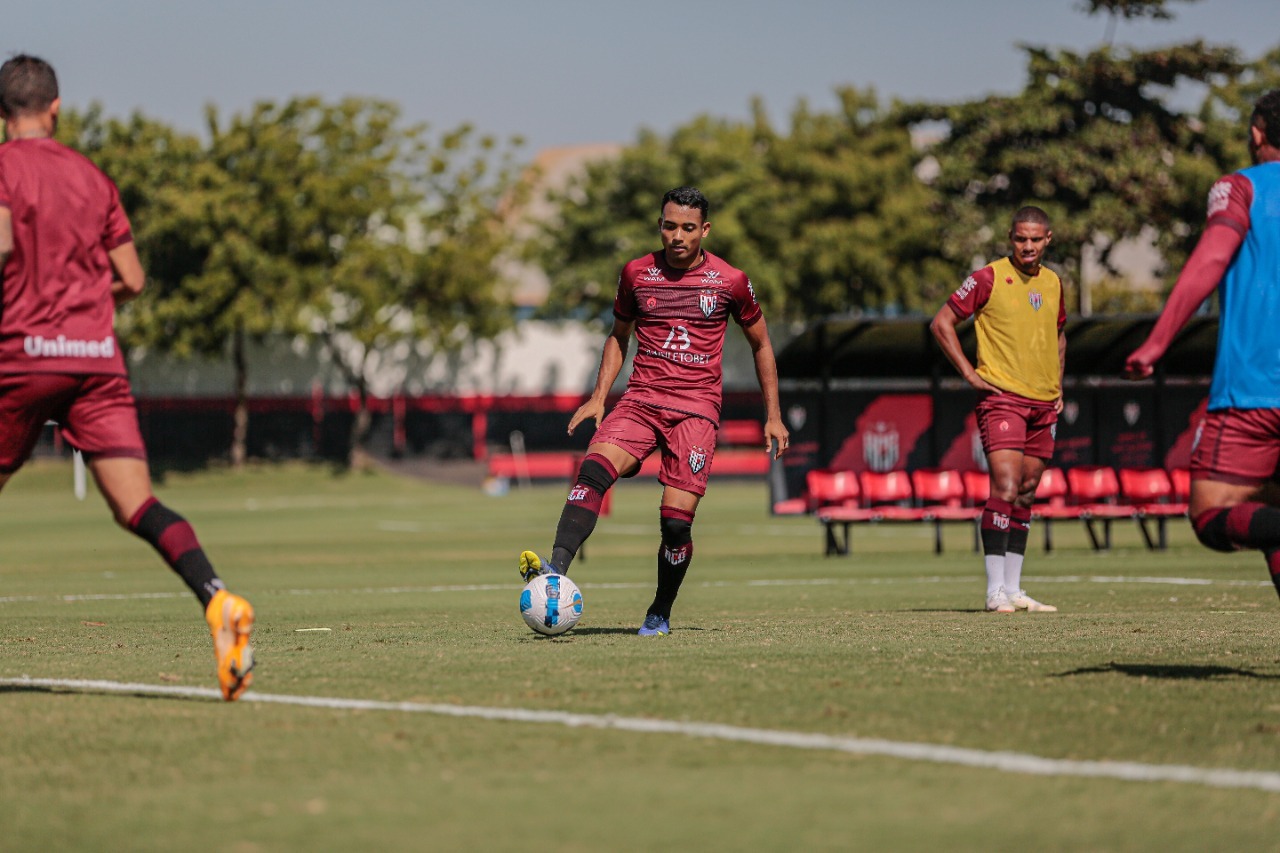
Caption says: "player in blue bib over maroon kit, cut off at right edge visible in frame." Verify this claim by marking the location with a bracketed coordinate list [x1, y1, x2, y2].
[1125, 90, 1280, 592]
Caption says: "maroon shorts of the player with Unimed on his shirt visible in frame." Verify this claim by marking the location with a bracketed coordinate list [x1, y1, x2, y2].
[0, 373, 147, 474]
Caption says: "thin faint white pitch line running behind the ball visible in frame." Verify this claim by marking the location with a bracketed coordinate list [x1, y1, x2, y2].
[0, 575, 1271, 605]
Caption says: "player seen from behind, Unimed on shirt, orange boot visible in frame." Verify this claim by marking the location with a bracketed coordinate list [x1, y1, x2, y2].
[0, 55, 253, 701]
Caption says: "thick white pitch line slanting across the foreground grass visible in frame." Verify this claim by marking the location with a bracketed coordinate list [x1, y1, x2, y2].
[0, 676, 1280, 793]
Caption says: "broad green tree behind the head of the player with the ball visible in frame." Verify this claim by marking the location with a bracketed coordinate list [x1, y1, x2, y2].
[543, 88, 938, 319]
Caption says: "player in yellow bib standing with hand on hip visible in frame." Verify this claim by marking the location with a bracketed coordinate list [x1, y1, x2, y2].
[929, 206, 1066, 613]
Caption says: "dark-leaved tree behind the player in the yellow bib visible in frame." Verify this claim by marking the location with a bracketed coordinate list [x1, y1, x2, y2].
[906, 0, 1242, 311]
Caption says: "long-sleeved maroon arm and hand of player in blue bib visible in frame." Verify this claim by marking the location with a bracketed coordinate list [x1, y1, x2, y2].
[1124, 223, 1244, 379]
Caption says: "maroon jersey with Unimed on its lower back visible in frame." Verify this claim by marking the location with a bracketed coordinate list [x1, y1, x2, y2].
[0, 138, 133, 375]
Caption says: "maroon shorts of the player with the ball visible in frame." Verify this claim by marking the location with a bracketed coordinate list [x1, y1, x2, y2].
[591, 400, 716, 496]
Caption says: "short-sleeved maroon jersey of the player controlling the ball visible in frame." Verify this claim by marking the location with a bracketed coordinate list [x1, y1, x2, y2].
[613, 251, 763, 423]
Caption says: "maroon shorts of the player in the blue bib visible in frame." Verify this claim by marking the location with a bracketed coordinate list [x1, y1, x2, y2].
[1192, 409, 1280, 485]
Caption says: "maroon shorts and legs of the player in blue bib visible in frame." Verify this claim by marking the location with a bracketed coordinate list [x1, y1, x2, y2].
[1187, 409, 1280, 593]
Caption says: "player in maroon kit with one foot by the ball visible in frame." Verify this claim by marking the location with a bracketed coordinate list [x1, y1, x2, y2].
[520, 187, 790, 637]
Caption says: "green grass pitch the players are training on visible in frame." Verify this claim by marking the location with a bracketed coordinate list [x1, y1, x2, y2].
[0, 464, 1280, 850]
